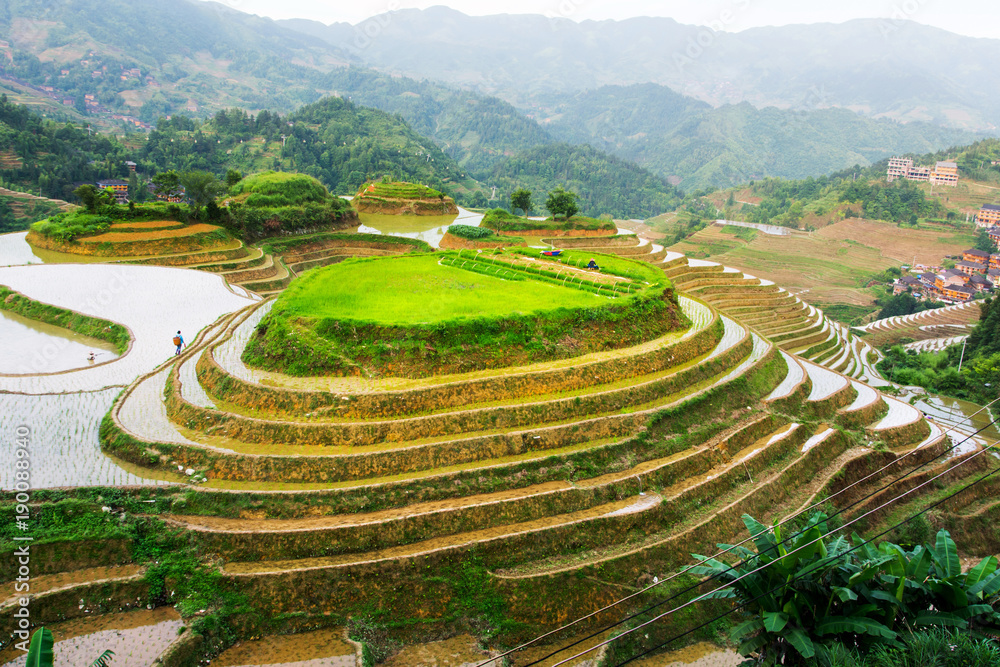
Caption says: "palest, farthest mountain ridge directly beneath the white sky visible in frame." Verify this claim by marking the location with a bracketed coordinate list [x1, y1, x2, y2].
[279, 7, 1000, 130]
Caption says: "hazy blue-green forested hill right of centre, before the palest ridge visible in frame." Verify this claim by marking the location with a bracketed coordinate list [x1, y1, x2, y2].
[545, 84, 976, 189]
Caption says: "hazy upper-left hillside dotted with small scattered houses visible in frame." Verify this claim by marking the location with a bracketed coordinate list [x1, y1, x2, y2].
[0, 0, 350, 122]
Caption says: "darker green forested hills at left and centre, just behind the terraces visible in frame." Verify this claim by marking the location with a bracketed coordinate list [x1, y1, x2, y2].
[0, 91, 680, 220]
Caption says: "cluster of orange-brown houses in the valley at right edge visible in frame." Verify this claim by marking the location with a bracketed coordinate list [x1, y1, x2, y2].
[892, 249, 1000, 303]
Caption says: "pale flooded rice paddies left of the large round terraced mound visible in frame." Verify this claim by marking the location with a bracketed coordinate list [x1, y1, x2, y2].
[0, 240, 258, 489]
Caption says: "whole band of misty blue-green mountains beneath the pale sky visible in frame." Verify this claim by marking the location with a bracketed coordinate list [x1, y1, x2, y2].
[0, 0, 1000, 204]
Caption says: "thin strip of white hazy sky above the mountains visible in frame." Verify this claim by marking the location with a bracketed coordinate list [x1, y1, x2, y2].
[218, 0, 1000, 38]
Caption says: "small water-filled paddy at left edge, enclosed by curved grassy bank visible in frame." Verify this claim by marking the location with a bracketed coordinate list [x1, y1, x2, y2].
[0, 311, 118, 375]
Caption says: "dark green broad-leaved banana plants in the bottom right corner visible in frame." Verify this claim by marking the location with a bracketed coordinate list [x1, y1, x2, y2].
[689, 512, 1000, 665]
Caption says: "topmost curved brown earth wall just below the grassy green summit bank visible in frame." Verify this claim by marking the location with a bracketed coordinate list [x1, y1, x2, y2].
[197, 315, 723, 418]
